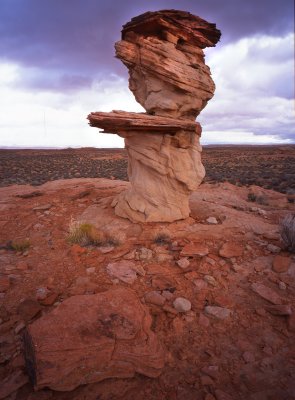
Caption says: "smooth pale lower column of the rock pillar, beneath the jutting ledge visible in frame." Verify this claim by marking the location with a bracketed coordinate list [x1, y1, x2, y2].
[113, 131, 205, 222]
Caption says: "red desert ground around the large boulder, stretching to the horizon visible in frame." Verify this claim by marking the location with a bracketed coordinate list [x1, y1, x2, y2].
[0, 146, 295, 400]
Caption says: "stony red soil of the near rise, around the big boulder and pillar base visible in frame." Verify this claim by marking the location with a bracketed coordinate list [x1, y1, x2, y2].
[0, 173, 295, 400]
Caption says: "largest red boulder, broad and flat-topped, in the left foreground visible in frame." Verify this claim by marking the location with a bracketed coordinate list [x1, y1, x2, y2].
[24, 289, 164, 391]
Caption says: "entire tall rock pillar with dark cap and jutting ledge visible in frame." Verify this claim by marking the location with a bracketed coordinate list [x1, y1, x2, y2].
[88, 10, 220, 222]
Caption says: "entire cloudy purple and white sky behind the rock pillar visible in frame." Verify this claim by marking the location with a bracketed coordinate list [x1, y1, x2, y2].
[0, 0, 295, 147]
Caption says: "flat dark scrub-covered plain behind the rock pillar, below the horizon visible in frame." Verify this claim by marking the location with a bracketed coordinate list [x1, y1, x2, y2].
[0, 145, 295, 193]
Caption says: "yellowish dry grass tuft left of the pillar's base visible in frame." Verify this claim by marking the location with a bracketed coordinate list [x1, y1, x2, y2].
[67, 220, 106, 246]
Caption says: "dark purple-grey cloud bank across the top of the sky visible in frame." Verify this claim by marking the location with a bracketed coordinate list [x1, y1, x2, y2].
[0, 0, 293, 89]
